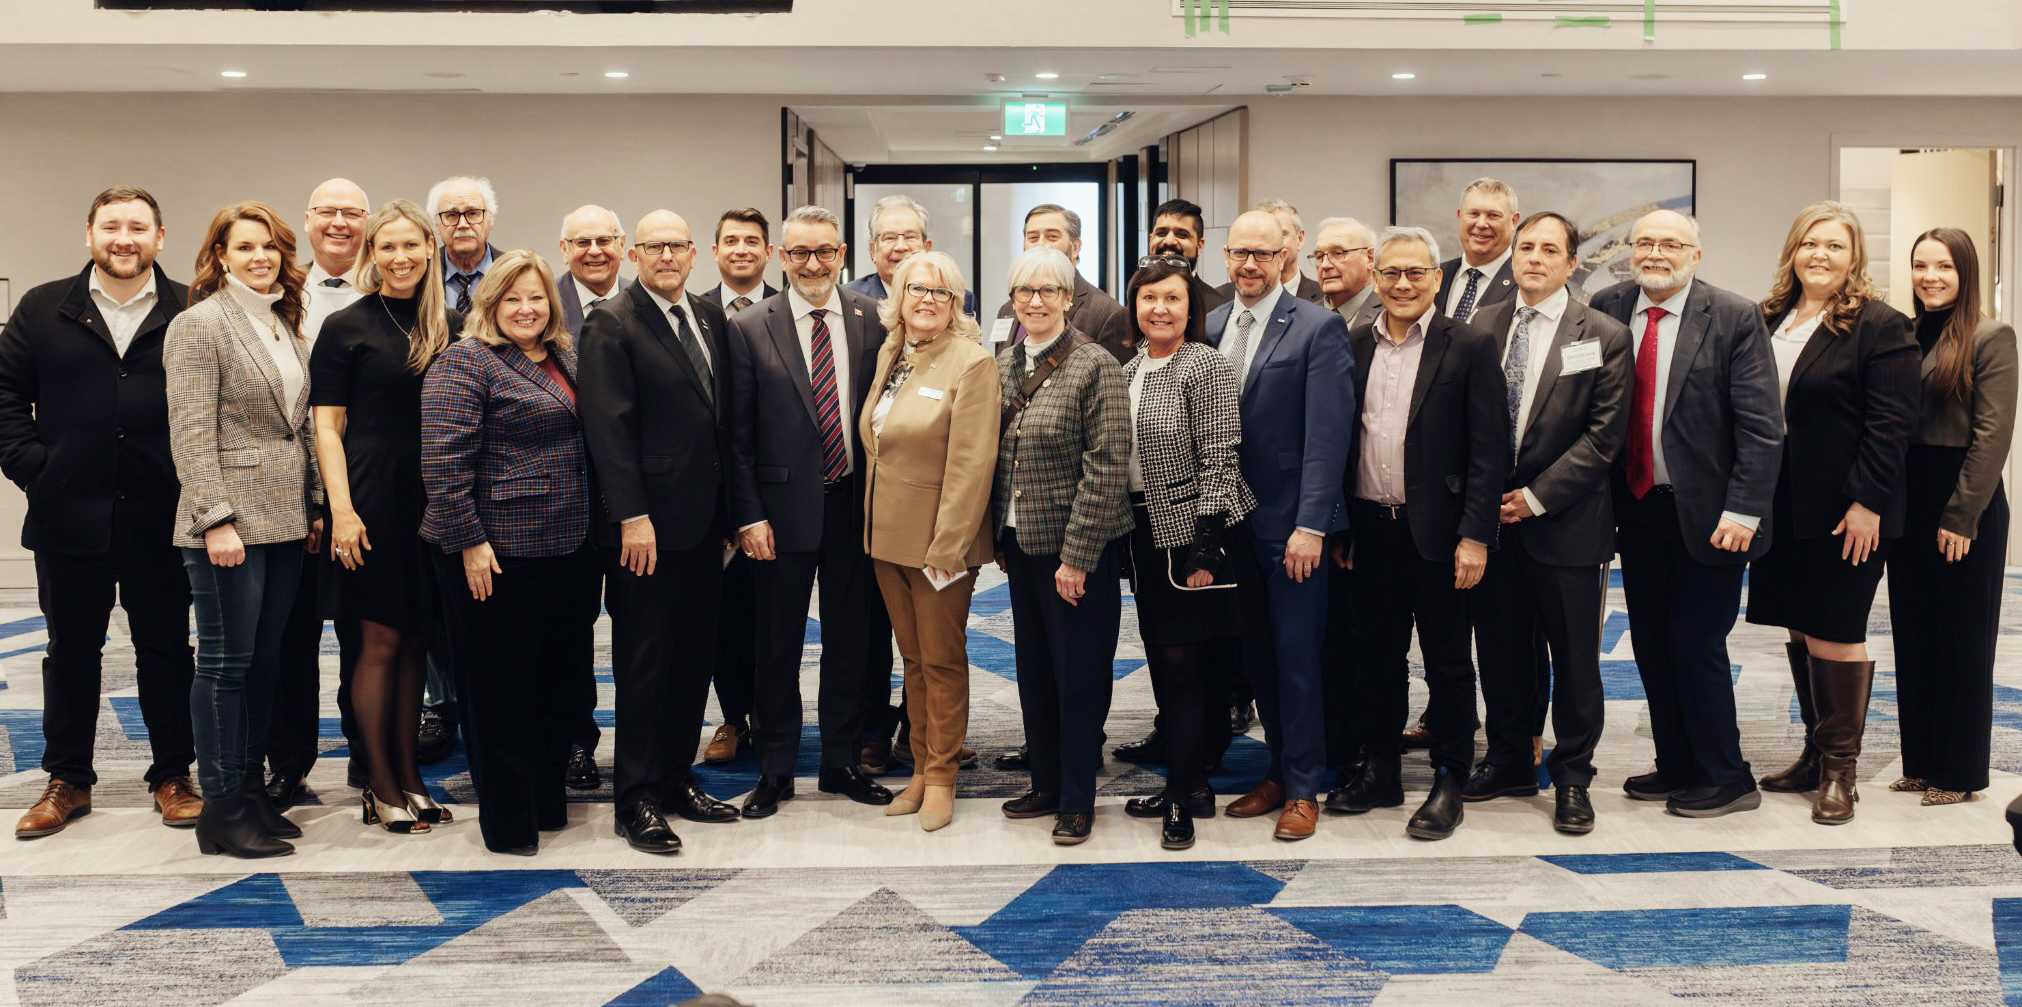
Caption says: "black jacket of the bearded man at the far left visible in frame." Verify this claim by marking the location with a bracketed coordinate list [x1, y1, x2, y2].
[0, 265, 190, 552]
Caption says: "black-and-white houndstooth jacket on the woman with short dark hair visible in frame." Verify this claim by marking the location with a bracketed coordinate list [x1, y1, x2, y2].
[1124, 342, 1258, 548]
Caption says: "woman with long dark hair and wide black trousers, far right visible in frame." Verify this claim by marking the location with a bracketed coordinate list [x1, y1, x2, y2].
[1889, 226, 2016, 807]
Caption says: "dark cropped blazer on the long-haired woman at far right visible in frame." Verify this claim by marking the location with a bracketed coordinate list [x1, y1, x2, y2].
[1915, 317, 2016, 538]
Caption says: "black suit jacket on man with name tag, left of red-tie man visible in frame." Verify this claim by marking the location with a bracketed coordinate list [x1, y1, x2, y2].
[1474, 297, 1636, 566]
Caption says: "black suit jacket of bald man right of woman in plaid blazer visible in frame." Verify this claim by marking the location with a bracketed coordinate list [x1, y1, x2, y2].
[578, 283, 730, 552]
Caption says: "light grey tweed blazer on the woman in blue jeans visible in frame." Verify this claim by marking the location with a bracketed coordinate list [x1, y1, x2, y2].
[162, 291, 324, 548]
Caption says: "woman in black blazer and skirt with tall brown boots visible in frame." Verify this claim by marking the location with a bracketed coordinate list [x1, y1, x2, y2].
[1749, 200, 1919, 825]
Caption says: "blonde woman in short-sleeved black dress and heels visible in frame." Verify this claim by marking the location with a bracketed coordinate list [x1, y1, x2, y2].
[309, 200, 463, 833]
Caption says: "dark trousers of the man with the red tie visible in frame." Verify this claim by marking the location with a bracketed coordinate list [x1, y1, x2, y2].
[1616, 487, 1753, 787]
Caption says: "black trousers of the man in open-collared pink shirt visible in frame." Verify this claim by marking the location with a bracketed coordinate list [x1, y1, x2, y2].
[1349, 501, 1476, 774]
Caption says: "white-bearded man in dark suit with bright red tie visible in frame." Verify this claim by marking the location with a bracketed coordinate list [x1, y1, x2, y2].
[1591, 210, 1783, 819]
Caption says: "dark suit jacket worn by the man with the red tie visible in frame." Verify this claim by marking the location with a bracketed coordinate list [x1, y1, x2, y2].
[1587, 279, 1779, 566]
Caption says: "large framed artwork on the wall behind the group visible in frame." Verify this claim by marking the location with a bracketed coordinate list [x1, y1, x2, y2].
[1391, 158, 1698, 293]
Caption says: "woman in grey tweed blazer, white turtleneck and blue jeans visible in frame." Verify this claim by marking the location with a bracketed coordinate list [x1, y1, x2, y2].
[162, 202, 324, 857]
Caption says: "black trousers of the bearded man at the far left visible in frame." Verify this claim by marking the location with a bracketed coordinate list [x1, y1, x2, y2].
[34, 546, 196, 789]
